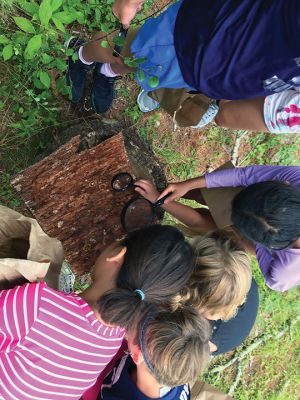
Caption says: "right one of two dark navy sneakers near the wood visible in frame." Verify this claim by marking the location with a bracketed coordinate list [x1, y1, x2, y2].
[91, 63, 122, 114]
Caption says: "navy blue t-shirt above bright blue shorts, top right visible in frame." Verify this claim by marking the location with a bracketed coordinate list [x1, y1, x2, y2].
[174, 0, 300, 100]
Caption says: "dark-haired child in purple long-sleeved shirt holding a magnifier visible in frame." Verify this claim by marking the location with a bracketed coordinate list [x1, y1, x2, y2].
[160, 165, 300, 292]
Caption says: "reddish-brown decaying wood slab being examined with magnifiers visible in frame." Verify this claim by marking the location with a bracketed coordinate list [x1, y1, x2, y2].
[12, 128, 166, 275]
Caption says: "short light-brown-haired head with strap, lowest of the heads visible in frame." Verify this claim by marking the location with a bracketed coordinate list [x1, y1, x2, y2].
[128, 307, 211, 387]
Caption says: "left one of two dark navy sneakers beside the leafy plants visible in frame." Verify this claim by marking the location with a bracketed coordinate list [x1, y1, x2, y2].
[65, 36, 95, 103]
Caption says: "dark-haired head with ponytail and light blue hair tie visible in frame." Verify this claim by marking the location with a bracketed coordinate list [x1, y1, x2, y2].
[98, 225, 194, 329]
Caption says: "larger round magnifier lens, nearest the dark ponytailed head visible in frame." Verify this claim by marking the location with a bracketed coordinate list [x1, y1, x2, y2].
[121, 198, 153, 232]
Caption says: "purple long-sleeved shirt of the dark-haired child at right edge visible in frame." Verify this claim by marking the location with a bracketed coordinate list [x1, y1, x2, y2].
[205, 165, 300, 292]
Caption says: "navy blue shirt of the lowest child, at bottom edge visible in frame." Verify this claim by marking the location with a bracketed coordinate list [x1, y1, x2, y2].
[97, 356, 190, 400]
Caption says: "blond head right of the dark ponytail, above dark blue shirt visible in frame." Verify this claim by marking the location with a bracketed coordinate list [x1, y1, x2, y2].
[181, 232, 251, 320]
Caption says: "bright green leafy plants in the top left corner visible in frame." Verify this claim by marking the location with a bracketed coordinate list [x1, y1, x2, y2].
[0, 0, 119, 143]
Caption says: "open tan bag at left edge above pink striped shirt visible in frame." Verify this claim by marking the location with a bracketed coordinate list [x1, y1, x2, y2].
[0, 205, 64, 290]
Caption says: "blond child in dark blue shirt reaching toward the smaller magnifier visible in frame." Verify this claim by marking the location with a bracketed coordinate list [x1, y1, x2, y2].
[135, 180, 258, 355]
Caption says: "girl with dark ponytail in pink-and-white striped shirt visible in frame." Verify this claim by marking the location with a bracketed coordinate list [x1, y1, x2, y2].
[0, 226, 193, 400]
